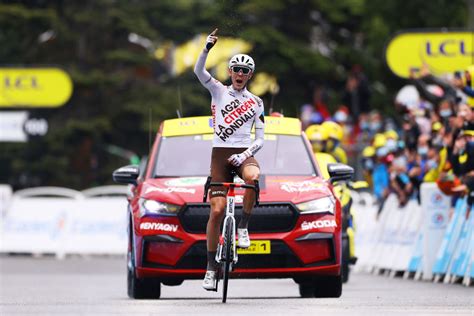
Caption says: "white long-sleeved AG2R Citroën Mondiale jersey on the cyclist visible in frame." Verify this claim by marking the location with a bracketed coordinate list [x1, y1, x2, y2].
[194, 52, 265, 149]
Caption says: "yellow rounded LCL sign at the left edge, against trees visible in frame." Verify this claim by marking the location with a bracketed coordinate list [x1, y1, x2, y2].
[0, 68, 72, 108]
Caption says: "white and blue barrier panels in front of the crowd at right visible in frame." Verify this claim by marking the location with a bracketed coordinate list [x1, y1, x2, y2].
[352, 183, 474, 286]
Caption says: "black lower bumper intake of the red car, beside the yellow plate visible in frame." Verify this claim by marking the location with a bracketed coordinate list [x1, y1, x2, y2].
[175, 240, 303, 269]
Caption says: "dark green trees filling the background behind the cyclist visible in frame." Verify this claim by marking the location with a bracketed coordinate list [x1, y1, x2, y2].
[0, 0, 468, 189]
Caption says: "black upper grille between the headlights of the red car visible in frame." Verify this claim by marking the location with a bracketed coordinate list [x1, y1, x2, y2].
[178, 203, 299, 234]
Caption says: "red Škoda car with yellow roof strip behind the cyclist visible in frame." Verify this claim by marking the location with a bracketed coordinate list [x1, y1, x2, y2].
[113, 116, 353, 298]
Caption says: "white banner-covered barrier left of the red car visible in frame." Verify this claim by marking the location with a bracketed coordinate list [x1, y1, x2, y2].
[0, 186, 128, 258]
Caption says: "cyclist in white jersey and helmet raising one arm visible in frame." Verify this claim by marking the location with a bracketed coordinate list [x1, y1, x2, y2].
[194, 29, 265, 291]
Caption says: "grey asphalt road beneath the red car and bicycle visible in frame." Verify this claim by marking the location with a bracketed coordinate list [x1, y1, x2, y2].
[0, 256, 474, 316]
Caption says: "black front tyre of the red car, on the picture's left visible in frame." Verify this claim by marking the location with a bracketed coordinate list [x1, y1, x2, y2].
[127, 226, 161, 299]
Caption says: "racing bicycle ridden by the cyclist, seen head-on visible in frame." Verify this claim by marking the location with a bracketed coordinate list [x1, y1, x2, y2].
[203, 177, 260, 303]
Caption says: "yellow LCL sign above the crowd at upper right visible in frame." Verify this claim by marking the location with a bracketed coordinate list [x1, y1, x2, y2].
[385, 31, 474, 78]
